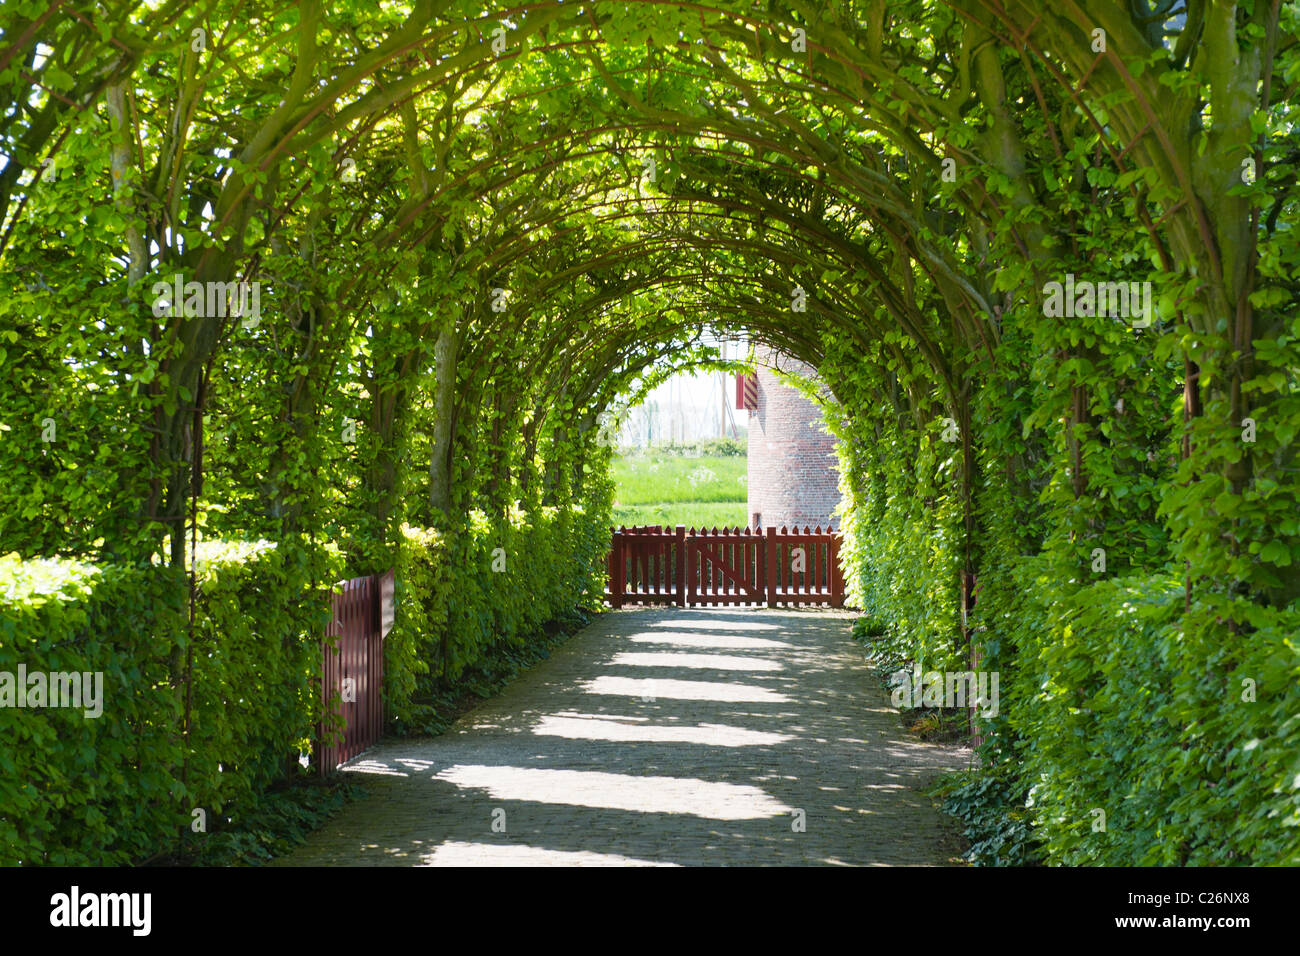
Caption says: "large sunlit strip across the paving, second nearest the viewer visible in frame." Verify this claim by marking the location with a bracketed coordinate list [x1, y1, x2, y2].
[437, 765, 790, 819]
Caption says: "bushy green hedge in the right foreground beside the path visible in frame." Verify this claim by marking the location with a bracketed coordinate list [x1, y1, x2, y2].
[1006, 575, 1300, 866]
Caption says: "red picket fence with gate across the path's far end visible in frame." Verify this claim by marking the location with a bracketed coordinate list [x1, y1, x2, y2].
[606, 524, 844, 607]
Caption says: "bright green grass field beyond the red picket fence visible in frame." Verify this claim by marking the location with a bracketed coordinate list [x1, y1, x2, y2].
[614, 454, 749, 528]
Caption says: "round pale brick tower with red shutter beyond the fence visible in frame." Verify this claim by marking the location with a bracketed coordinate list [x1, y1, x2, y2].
[736, 349, 840, 528]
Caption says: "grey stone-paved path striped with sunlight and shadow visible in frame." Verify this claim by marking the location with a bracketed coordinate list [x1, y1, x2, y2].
[276, 609, 971, 866]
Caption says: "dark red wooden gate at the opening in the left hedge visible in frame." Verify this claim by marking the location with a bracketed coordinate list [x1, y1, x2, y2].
[315, 571, 394, 777]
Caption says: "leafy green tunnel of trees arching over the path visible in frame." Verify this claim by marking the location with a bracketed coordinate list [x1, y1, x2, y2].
[0, 0, 1300, 864]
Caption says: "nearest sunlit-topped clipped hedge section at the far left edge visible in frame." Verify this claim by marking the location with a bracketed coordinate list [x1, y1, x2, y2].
[0, 554, 186, 866]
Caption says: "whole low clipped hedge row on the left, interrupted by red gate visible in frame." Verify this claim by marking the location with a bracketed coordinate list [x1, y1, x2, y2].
[0, 493, 608, 865]
